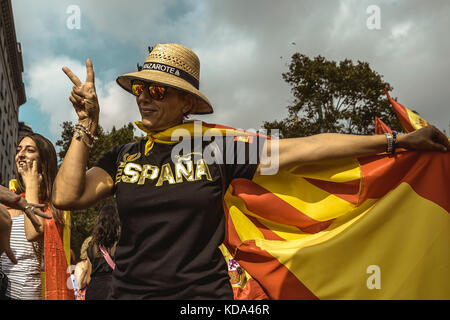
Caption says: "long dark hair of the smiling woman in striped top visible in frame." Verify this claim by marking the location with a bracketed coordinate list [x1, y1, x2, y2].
[14, 133, 64, 225]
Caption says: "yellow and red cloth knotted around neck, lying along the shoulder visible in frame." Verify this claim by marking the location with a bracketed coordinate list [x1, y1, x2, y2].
[134, 121, 257, 156]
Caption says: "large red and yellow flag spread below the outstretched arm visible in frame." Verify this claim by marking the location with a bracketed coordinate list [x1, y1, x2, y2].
[224, 152, 450, 299]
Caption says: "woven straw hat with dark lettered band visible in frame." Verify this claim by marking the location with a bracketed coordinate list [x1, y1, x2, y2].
[116, 43, 213, 114]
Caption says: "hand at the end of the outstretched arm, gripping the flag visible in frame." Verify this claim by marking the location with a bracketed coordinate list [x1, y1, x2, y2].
[398, 126, 450, 152]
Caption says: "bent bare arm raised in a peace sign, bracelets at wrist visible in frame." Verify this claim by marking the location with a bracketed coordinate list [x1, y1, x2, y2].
[52, 59, 114, 210]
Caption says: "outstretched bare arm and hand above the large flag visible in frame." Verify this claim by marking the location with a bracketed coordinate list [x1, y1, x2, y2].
[256, 126, 450, 174]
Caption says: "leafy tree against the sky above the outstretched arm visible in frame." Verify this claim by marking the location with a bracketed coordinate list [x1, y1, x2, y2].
[264, 53, 402, 138]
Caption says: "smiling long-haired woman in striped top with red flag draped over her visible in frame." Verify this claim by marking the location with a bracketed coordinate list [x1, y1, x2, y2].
[1, 133, 73, 300]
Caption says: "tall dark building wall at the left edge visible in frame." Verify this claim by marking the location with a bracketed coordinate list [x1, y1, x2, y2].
[0, 0, 26, 186]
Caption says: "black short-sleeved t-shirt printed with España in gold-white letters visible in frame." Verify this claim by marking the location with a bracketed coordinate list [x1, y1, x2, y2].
[96, 136, 265, 299]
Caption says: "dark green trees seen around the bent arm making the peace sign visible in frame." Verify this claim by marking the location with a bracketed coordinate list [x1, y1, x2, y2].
[56, 121, 142, 258]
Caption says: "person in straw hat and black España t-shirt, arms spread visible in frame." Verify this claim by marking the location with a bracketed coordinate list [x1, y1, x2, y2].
[53, 44, 449, 299]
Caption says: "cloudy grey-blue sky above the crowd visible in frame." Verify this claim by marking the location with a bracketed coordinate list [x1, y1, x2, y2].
[13, 0, 450, 142]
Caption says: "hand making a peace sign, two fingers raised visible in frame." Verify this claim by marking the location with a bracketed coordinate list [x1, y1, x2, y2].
[62, 59, 100, 134]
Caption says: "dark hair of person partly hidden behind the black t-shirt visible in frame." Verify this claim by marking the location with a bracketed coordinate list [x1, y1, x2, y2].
[92, 205, 120, 248]
